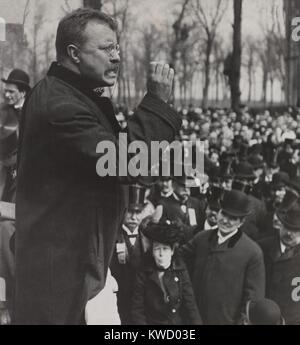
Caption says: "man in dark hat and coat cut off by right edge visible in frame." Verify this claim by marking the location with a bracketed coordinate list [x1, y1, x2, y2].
[259, 191, 300, 325]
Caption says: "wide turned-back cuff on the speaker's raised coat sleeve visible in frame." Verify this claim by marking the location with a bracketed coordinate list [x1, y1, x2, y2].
[140, 92, 182, 132]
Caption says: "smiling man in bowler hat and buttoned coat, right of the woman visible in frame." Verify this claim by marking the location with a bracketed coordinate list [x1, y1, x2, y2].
[181, 190, 265, 325]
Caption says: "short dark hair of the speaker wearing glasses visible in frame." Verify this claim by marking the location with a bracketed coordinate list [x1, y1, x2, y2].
[55, 8, 118, 61]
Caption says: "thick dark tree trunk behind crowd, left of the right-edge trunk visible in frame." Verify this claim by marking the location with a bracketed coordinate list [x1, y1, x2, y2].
[230, 0, 243, 113]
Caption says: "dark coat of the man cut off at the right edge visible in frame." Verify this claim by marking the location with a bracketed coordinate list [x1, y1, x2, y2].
[259, 236, 300, 325]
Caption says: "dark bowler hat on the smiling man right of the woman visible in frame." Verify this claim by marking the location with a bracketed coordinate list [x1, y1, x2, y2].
[221, 190, 251, 217]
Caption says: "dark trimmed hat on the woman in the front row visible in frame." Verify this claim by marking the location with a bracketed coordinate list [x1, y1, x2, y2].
[143, 220, 183, 246]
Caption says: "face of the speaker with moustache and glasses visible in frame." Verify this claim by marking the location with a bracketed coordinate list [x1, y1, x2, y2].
[78, 21, 120, 87]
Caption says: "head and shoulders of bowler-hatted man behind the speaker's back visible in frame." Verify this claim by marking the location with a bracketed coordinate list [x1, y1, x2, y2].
[0, 69, 30, 120]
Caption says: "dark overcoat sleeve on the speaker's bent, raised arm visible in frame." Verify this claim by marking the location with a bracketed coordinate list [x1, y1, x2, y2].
[47, 94, 181, 182]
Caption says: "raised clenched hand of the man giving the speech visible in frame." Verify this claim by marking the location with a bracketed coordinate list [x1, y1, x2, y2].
[148, 62, 174, 102]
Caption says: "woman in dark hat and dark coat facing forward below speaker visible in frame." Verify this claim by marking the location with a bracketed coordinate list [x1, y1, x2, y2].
[132, 222, 202, 325]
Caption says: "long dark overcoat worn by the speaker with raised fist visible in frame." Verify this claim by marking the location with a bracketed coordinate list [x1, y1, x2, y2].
[16, 64, 181, 324]
